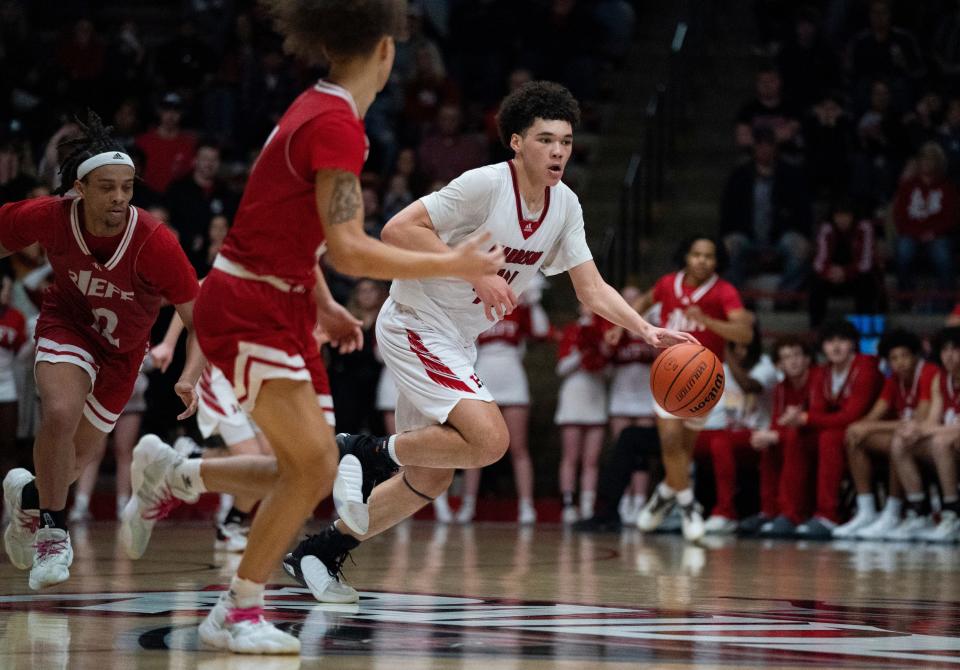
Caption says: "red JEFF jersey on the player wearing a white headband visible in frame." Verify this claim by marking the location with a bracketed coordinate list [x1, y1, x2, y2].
[0, 197, 198, 353]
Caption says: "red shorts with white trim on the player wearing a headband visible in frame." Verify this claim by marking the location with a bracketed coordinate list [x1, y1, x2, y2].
[34, 313, 146, 433]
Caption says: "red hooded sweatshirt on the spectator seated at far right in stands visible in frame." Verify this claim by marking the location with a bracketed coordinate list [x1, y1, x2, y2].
[893, 177, 960, 240]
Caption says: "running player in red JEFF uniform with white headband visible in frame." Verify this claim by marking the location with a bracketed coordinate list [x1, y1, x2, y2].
[0, 113, 203, 589]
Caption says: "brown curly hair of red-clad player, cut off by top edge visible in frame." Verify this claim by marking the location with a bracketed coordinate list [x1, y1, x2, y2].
[260, 0, 407, 63]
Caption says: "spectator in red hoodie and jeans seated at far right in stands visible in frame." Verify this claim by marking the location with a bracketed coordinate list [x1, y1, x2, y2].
[893, 142, 960, 309]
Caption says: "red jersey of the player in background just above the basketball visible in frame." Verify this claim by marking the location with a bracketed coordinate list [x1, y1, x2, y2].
[653, 271, 743, 360]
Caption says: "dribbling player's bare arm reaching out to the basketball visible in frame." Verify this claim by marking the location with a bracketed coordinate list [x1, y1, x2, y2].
[570, 260, 697, 347]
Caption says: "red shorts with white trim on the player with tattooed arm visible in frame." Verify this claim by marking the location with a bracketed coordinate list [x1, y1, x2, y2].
[193, 269, 334, 426]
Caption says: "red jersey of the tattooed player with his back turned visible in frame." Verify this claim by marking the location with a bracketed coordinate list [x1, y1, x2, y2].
[220, 81, 366, 287]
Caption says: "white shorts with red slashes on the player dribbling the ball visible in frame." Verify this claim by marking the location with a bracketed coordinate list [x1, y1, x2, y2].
[377, 298, 493, 430]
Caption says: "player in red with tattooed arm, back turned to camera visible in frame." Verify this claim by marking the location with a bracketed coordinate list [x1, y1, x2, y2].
[122, 0, 503, 653]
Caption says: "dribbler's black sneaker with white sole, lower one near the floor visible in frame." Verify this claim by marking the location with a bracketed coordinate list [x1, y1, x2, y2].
[283, 525, 360, 603]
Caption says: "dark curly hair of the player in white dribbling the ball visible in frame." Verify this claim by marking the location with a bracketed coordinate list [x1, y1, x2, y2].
[497, 81, 580, 149]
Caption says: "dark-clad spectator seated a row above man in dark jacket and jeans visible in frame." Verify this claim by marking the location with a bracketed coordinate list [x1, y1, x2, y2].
[735, 64, 800, 153]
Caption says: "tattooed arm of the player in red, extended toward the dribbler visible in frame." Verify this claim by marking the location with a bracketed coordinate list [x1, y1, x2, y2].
[315, 170, 503, 281]
